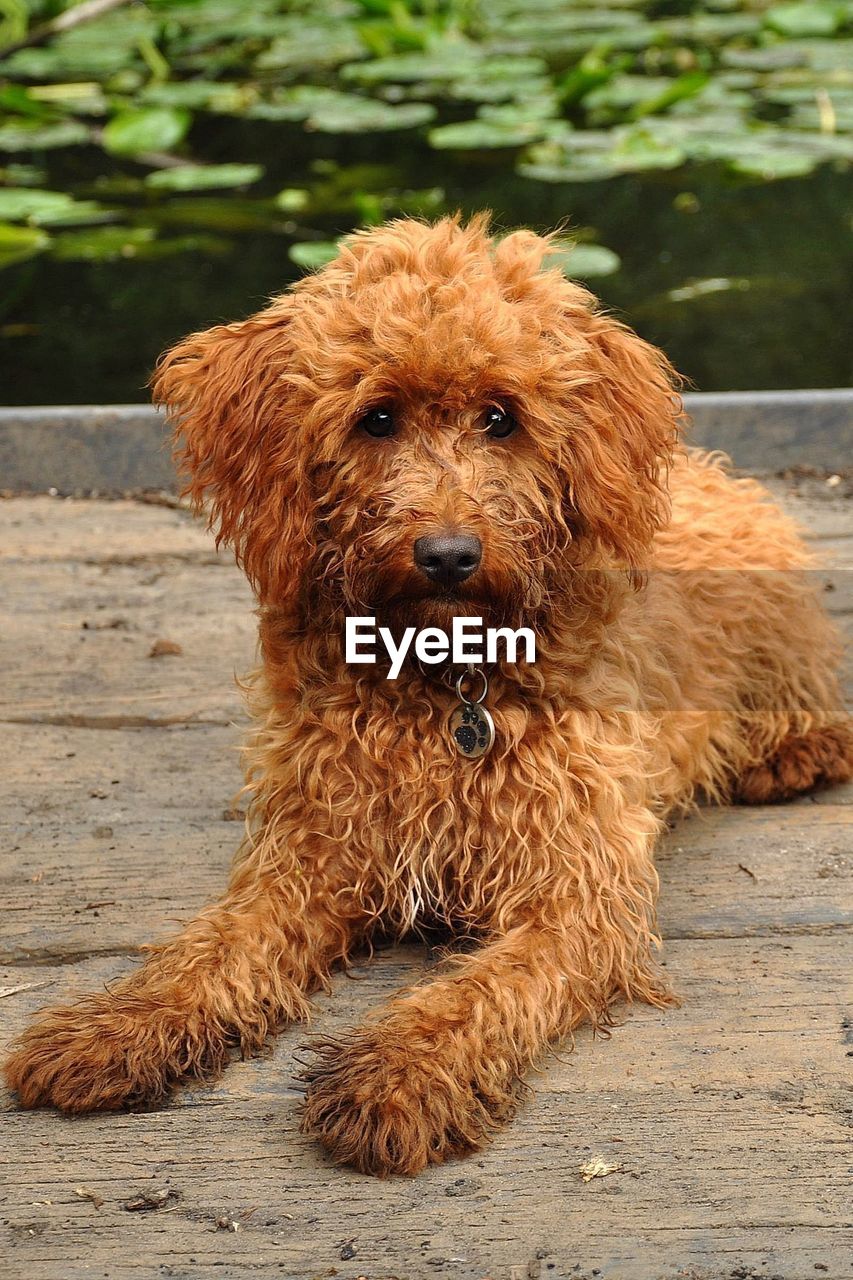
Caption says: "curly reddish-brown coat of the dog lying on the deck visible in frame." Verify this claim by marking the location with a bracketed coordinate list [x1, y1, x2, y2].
[6, 218, 853, 1174]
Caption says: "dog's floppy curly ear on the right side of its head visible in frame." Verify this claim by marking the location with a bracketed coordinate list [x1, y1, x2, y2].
[560, 310, 683, 568]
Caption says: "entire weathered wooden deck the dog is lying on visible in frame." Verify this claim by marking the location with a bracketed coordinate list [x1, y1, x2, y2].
[0, 485, 853, 1280]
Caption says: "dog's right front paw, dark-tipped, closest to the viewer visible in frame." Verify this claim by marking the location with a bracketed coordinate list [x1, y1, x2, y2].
[295, 1024, 514, 1178]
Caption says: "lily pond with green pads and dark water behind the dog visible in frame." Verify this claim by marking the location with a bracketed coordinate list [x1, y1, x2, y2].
[0, 0, 853, 403]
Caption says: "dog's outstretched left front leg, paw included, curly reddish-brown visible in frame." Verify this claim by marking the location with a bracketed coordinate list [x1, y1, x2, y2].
[5, 844, 364, 1112]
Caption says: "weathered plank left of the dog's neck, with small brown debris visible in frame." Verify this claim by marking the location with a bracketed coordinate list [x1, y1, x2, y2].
[0, 561, 256, 726]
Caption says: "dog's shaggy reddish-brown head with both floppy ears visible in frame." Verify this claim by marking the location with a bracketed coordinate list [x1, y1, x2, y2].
[155, 218, 679, 626]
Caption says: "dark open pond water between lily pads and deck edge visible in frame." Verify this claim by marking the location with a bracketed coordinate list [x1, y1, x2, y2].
[0, 123, 853, 404]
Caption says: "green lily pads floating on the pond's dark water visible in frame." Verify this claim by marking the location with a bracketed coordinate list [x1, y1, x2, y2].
[0, 0, 853, 276]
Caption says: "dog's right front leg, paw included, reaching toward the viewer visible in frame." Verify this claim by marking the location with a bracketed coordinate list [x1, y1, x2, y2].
[302, 919, 669, 1176]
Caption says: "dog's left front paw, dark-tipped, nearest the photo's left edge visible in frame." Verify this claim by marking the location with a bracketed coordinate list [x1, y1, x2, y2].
[4, 996, 222, 1112]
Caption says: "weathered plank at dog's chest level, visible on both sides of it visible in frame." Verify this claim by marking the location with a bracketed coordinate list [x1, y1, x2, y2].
[0, 724, 853, 961]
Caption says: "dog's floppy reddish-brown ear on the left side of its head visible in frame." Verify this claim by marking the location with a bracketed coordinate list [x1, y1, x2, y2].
[152, 294, 311, 600]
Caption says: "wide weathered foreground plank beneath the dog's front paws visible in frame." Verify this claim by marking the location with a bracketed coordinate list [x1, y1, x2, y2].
[0, 937, 849, 1280]
